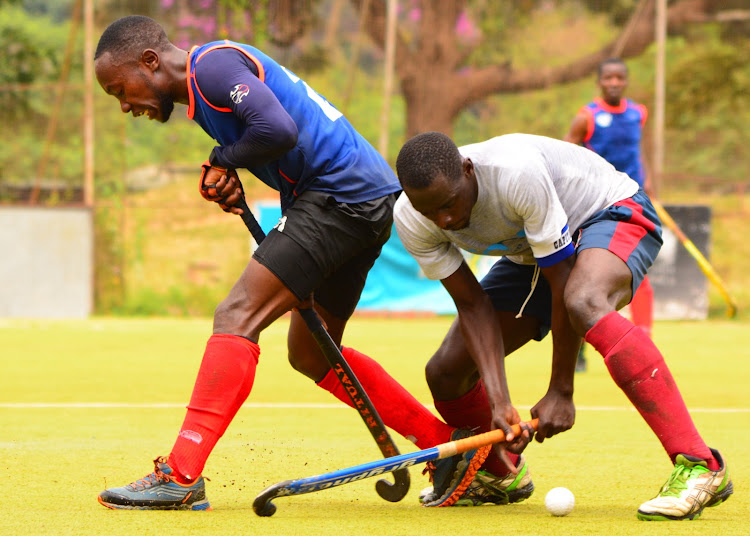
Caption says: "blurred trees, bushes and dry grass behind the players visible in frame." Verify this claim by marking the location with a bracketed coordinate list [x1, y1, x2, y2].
[0, 0, 750, 314]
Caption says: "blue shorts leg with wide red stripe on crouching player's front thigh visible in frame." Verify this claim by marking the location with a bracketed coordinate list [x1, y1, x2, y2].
[576, 190, 662, 293]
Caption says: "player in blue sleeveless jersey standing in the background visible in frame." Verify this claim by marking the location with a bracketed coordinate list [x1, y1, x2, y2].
[563, 58, 654, 371]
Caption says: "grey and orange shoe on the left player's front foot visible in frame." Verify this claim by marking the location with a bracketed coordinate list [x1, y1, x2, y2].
[99, 457, 211, 510]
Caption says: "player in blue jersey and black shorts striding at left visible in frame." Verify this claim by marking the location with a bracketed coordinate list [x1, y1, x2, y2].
[95, 16, 489, 510]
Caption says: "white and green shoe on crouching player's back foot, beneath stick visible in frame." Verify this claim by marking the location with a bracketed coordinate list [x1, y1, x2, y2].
[419, 455, 534, 506]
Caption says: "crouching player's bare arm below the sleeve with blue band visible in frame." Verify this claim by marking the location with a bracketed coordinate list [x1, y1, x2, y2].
[531, 255, 581, 443]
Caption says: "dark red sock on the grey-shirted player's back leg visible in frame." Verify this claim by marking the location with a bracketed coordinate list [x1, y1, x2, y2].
[435, 380, 519, 477]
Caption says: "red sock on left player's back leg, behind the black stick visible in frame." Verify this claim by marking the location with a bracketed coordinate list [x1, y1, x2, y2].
[318, 347, 453, 449]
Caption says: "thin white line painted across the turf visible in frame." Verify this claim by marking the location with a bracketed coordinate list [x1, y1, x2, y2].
[0, 402, 750, 413]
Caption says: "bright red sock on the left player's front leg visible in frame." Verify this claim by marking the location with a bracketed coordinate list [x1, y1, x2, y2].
[169, 335, 260, 480]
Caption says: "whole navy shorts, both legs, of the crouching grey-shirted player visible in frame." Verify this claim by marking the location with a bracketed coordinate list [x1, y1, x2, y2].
[480, 190, 662, 341]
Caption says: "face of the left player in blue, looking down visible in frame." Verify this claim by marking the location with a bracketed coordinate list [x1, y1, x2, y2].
[95, 54, 174, 123]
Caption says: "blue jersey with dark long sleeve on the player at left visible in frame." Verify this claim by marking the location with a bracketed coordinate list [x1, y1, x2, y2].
[187, 41, 401, 210]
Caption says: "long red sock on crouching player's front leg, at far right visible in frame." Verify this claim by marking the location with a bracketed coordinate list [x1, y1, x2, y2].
[586, 312, 719, 470]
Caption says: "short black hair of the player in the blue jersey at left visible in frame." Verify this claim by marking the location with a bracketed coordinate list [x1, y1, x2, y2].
[94, 15, 171, 63]
